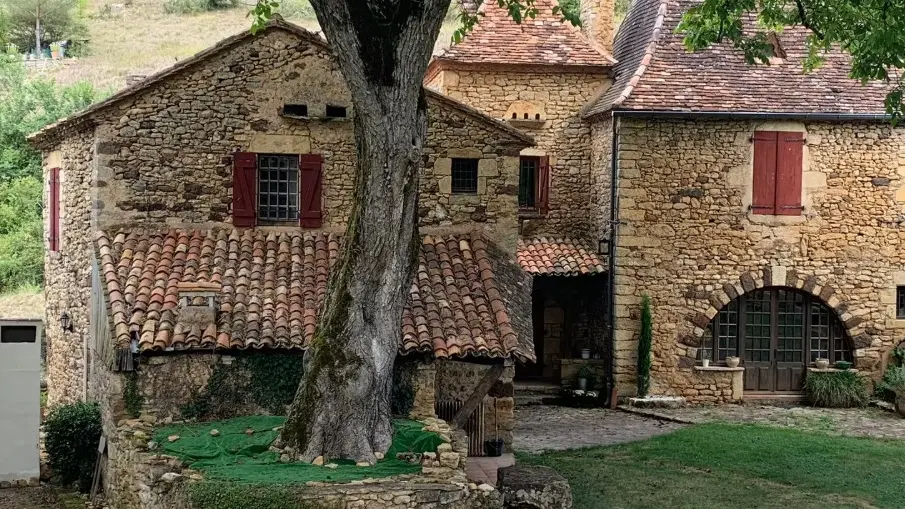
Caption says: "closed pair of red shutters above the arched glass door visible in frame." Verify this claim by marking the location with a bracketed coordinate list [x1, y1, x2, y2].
[751, 131, 804, 216]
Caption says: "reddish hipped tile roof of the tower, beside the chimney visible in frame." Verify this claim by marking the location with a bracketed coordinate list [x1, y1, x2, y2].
[435, 0, 615, 67]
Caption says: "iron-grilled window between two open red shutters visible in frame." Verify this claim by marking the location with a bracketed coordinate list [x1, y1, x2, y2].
[258, 154, 299, 221]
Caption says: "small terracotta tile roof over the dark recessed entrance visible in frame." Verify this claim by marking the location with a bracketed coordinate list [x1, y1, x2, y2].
[518, 237, 606, 276]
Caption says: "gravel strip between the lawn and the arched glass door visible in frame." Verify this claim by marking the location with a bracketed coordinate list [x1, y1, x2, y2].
[628, 404, 905, 439]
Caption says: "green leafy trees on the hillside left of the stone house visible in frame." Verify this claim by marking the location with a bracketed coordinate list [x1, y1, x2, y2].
[0, 50, 99, 292]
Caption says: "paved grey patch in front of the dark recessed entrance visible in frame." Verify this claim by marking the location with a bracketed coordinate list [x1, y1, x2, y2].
[513, 405, 684, 452]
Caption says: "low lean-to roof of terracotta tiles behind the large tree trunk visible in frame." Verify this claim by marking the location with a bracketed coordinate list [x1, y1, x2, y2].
[96, 229, 534, 360]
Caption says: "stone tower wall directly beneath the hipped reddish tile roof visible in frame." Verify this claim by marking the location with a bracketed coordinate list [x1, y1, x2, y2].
[429, 70, 609, 238]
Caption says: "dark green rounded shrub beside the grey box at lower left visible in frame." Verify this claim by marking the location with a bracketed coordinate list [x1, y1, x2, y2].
[44, 403, 101, 492]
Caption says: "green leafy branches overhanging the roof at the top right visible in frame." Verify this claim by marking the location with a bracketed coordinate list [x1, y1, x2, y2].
[679, 0, 905, 121]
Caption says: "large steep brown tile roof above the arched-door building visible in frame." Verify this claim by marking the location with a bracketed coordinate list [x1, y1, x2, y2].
[584, 0, 889, 116]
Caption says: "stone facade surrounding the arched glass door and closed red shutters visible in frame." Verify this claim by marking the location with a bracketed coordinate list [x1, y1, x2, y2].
[615, 120, 905, 401]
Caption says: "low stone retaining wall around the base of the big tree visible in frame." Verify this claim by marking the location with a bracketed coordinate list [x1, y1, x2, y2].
[104, 415, 502, 509]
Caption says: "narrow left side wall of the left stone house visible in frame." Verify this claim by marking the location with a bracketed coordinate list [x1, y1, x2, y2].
[43, 131, 94, 406]
